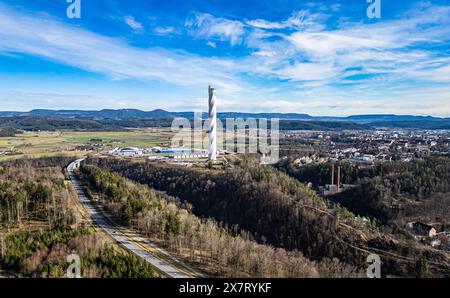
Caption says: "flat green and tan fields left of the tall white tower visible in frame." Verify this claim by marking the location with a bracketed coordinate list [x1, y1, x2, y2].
[0, 128, 173, 160]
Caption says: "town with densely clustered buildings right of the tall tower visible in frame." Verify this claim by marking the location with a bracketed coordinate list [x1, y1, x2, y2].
[281, 129, 450, 165]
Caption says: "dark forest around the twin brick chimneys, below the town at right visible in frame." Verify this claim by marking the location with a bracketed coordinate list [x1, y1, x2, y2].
[276, 157, 450, 226]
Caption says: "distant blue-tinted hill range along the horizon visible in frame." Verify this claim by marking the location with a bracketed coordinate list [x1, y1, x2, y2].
[0, 109, 450, 129]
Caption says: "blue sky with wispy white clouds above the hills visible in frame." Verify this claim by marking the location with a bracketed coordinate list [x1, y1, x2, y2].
[0, 0, 450, 116]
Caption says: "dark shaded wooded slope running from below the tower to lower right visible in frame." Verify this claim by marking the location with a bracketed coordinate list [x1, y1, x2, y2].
[88, 158, 449, 276]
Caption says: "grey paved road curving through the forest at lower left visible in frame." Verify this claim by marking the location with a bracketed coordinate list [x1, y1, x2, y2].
[67, 159, 190, 278]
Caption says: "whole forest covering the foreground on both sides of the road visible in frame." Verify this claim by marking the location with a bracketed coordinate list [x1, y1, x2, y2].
[0, 157, 449, 277]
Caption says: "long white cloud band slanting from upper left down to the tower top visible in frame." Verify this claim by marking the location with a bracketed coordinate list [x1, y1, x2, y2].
[0, 6, 243, 92]
